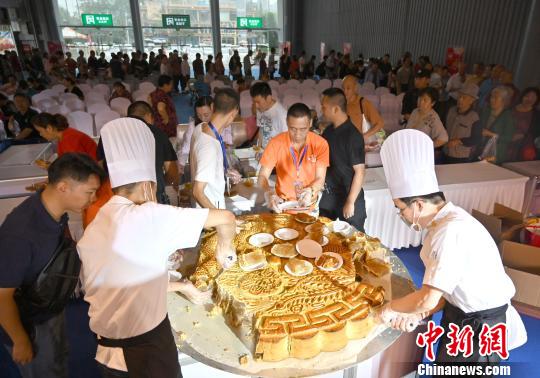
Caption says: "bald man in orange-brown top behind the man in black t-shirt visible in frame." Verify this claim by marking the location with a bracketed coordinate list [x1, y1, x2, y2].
[343, 75, 384, 143]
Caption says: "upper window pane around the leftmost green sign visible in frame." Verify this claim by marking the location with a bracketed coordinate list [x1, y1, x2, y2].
[56, 0, 132, 26]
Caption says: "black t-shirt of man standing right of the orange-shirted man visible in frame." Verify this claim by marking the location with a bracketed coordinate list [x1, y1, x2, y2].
[322, 119, 365, 194]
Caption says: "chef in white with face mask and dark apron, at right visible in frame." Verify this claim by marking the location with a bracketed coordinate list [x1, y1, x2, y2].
[381, 130, 526, 364]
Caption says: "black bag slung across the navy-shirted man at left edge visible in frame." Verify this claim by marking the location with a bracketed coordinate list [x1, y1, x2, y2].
[15, 235, 81, 321]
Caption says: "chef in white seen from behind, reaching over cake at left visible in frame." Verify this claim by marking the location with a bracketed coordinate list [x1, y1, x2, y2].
[77, 118, 236, 378]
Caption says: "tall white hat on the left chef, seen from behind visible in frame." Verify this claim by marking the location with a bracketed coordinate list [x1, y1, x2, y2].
[101, 118, 156, 188]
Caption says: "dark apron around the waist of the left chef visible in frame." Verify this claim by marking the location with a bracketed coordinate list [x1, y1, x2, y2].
[97, 316, 182, 378]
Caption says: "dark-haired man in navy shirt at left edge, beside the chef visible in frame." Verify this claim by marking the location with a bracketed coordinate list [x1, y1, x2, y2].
[0, 153, 102, 378]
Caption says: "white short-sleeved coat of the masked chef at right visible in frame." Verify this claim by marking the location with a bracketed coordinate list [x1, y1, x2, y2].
[420, 202, 515, 313]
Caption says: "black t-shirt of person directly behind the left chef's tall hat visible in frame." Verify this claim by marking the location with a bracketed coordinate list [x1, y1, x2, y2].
[96, 117, 178, 203]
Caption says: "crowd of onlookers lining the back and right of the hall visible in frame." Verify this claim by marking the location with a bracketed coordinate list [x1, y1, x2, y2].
[0, 44, 540, 163]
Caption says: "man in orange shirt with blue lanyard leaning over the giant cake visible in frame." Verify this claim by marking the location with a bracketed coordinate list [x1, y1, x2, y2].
[257, 103, 330, 213]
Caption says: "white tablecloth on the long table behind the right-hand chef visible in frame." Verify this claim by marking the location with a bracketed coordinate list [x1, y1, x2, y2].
[364, 162, 528, 249]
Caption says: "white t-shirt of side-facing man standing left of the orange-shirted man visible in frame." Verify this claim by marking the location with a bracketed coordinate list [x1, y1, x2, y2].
[189, 123, 225, 209]
